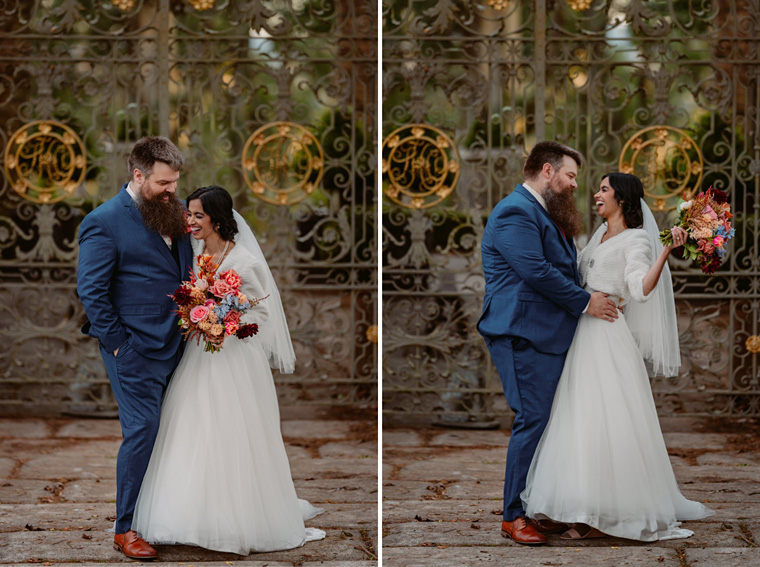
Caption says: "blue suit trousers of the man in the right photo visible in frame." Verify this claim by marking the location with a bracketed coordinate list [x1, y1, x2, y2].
[486, 337, 567, 522]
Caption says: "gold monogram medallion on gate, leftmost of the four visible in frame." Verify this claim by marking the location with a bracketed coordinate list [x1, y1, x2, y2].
[3, 120, 87, 203]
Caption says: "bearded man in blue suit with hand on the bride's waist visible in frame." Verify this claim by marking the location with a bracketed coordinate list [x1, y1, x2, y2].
[478, 142, 618, 545]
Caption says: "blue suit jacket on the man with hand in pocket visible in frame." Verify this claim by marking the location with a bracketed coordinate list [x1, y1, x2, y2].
[77, 189, 192, 360]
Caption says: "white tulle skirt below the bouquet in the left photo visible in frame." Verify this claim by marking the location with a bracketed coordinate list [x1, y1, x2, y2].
[132, 338, 325, 555]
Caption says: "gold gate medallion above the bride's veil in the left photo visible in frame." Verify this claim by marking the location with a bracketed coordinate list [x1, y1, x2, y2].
[243, 122, 325, 205]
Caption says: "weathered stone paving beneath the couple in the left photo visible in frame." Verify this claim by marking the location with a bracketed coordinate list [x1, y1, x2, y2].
[0, 408, 378, 567]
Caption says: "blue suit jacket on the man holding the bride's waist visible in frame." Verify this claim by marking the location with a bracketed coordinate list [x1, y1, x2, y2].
[478, 185, 590, 354]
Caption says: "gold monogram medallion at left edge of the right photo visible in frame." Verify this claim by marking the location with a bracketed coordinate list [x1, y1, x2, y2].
[382, 124, 460, 209]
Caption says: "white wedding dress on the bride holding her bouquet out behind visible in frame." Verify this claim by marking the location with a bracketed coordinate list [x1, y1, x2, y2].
[521, 225, 714, 541]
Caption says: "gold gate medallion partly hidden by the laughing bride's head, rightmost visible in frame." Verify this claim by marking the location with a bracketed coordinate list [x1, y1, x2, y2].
[618, 126, 704, 211]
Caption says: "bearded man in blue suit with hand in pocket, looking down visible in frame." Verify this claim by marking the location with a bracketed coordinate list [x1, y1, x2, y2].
[77, 136, 192, 559]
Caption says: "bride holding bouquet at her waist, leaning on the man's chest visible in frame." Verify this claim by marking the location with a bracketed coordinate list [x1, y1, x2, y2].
[132, 186, 325, 555]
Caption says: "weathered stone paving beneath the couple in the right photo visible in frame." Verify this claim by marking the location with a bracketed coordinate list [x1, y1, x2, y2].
[383, 419, 760, 567]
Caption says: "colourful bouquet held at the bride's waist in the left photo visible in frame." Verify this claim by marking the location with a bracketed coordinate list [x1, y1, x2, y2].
[169, 255, 269, 352]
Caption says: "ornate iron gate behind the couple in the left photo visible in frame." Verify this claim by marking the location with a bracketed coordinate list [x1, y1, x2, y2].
[0, 0, 377, 414]
